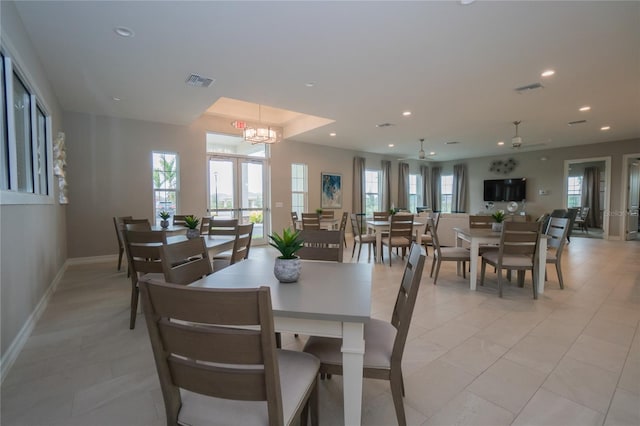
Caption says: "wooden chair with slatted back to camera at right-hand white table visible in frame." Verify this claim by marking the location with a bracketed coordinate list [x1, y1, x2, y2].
[480, 221, 542, 299]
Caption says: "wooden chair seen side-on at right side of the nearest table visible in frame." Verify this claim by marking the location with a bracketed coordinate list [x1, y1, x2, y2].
[304, 244, 425, 425]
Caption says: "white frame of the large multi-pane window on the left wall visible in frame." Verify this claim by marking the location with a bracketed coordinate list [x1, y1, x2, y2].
[0, 50, 55, 205]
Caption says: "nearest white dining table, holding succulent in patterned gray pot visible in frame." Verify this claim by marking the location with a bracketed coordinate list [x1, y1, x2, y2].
[141, 254, 373, 425]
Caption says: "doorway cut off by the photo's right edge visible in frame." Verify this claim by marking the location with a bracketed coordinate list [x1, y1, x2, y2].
[620, 153, 640, 241]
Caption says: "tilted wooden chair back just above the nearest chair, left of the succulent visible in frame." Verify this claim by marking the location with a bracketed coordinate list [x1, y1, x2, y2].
[160, 237, 213, 285]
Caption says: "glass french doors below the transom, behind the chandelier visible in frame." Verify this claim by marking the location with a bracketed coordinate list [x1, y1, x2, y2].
[207, 155, 270, 244]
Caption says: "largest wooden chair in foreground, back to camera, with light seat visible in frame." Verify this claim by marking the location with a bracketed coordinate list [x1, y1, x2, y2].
[141, 282, 320, 426]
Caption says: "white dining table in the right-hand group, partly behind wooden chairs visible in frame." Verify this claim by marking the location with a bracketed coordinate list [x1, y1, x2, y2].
[453, 228, 547, 294]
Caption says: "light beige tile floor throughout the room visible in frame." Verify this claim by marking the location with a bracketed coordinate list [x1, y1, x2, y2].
[0, 238, 640, 426]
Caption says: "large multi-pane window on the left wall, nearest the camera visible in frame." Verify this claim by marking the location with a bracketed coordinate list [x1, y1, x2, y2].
[0, 53, 51, 204]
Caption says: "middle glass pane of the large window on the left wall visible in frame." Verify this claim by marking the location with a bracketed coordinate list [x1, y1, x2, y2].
[13, 74, 33, 192]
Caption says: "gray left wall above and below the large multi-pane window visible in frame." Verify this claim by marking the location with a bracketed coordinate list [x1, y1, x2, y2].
[0, 1, 67, 360]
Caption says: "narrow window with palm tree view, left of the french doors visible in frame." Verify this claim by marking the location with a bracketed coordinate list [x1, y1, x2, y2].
[153, 152, 178, 224]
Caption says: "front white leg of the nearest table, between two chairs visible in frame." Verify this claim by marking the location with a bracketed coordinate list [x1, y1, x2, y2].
[342, 322, 364, 426]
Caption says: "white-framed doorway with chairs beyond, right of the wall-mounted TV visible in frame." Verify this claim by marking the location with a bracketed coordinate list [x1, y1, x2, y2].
[563, 157, 611, 239]
